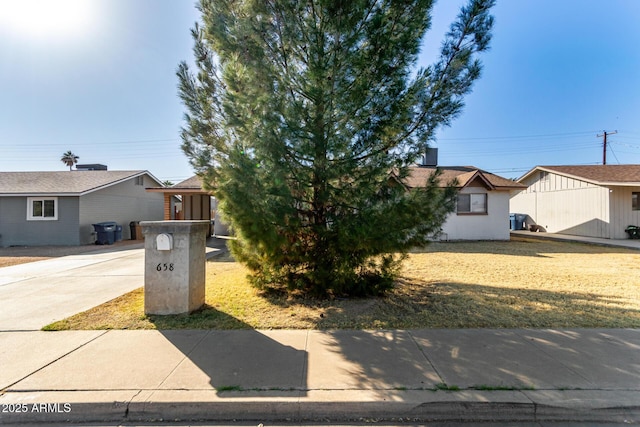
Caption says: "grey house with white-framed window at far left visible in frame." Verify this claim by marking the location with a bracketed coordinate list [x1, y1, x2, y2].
[0, 170, 168, 247]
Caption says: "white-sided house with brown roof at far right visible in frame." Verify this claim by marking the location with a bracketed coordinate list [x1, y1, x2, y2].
[510, 165, 640, 239]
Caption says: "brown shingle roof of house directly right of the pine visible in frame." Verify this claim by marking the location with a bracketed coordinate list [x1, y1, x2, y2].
[405, 166, 525, 190]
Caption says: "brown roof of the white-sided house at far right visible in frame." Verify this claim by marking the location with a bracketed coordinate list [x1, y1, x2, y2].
[518, 165, 640, 186]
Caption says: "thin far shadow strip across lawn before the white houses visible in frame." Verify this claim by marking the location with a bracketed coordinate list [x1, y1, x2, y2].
[410, 237, 640, 258]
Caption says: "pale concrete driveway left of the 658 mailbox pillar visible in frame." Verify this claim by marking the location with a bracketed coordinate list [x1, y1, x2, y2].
[0, 243, 144, 331]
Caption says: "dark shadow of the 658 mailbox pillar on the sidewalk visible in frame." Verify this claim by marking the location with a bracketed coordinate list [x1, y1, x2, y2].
[154, 313, 308, 398]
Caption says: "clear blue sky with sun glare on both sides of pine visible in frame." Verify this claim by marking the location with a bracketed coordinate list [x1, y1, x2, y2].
[0, 0, 640, 182]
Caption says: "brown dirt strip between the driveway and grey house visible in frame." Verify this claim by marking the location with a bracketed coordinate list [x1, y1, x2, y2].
[0, 240, 143, 267]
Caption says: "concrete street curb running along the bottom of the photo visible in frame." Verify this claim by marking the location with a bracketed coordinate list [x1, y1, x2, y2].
[0, 390, 640, 424]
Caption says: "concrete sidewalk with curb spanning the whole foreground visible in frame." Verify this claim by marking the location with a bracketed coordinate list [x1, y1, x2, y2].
[0, 329, 640, 424]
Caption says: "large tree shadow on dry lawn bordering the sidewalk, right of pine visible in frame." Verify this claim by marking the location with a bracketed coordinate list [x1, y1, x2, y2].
[264, 278, 640, 329]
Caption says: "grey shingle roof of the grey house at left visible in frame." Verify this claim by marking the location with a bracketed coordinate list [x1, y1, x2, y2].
[0, 171, 162, 196]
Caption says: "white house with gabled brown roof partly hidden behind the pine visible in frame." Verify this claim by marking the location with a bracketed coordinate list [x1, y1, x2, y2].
[405, 166, 524, 240]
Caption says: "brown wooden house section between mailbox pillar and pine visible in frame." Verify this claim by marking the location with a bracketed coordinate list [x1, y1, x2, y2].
[147, 175, 228, 235]
